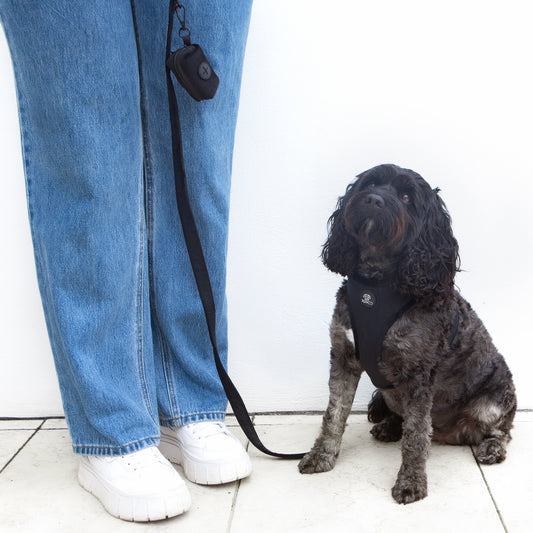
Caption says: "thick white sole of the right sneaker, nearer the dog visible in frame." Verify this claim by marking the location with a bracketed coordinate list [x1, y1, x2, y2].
[159, 433, 252, 485]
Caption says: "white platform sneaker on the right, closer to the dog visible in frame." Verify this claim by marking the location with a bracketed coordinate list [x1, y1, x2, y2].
[159, 422, 252, 485]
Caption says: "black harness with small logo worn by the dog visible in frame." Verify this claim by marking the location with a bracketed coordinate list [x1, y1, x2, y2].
[346, 277, 459, 389]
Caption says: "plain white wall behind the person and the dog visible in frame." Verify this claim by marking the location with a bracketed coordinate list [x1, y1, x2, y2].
[0, 0, 533, 416]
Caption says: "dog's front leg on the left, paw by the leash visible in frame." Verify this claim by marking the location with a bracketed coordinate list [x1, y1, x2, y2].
[298, 323, 362, 474]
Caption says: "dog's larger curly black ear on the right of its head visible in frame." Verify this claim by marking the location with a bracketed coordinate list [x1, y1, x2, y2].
[398, 189, 459, 299]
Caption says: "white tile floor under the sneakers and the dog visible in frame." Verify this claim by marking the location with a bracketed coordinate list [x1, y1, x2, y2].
[0, 412, 533, 533]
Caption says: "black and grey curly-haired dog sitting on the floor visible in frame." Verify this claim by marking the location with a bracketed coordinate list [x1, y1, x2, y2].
[299, 165, 516, 503]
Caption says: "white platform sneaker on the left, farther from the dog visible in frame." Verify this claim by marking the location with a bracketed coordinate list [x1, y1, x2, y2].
[78, 446, 191, 522]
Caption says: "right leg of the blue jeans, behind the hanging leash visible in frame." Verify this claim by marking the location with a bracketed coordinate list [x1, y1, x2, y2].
[132, 0, 252, 425]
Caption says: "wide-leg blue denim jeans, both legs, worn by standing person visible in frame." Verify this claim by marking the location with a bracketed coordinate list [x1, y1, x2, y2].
[0, 0, 252, 455]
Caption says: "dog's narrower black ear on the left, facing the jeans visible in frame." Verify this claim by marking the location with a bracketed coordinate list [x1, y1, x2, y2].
[322, 183, 359, 276]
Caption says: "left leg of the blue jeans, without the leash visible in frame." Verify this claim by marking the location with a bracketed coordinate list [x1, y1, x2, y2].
[0, 0, 160, 455]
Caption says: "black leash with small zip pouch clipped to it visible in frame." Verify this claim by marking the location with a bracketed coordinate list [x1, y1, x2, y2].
[166, 0, 305, 459]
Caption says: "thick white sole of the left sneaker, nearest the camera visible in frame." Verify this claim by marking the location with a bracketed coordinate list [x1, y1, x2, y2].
[78, 461, 191, 522]
